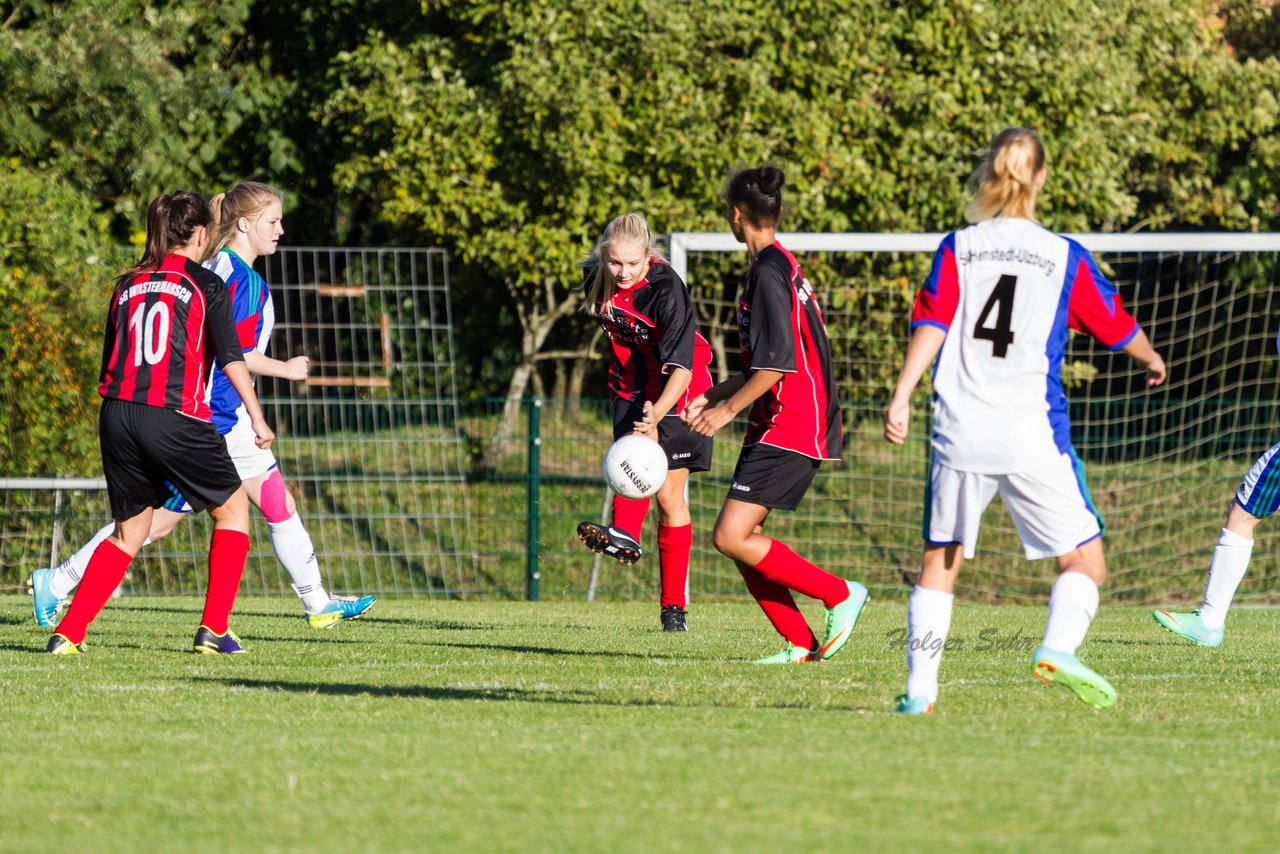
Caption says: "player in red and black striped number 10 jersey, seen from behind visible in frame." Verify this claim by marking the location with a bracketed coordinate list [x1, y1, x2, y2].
[47, 192, 274, 654]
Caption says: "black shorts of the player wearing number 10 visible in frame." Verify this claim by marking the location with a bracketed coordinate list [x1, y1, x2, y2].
[97, 398, 241, 521]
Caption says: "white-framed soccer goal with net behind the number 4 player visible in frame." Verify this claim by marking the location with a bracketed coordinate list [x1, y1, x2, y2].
[645, 233, 1280, 599]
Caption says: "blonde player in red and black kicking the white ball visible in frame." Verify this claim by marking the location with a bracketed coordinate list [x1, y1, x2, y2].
[577, 214, 712, 631]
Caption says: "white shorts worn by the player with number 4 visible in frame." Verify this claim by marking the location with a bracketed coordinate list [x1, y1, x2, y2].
[924, 453, 1105, 561]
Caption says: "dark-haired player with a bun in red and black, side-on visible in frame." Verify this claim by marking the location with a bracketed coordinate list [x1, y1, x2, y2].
[684, 166, 867, 665]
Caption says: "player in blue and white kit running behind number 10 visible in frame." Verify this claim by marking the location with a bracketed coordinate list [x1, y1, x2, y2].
[31, 182, 376, 629]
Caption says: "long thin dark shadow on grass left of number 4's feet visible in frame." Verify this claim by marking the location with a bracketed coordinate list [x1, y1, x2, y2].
[199, 676, 884, 712]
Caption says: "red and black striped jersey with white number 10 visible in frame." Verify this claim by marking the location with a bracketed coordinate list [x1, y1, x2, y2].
[97, 255, 244, 421]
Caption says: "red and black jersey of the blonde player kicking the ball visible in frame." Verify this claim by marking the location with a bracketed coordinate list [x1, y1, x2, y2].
[598, 259, 712, 415]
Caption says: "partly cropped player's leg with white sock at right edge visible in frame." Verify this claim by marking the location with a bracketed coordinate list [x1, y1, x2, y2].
[1152, 327, 1280, 647]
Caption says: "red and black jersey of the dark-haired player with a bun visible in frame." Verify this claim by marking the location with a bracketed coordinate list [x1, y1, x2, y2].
[737, 243, 844, 460]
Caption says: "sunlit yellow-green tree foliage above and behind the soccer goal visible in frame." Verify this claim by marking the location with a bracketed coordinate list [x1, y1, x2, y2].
[316, 0, 1280, 404]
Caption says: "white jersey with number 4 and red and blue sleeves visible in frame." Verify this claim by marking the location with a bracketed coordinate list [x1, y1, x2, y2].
[911, 218, 1138, 474]
